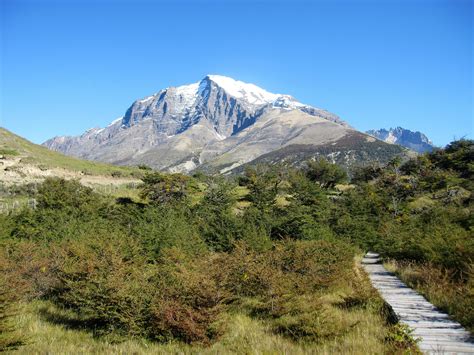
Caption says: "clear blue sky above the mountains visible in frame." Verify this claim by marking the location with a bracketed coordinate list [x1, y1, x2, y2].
[0, 0, 474, 145]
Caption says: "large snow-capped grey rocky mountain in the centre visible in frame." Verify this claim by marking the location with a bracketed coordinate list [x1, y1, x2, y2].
[43, 75, 401, 172]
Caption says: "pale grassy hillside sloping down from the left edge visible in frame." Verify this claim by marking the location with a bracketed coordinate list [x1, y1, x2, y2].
[0, 127, 138, 177]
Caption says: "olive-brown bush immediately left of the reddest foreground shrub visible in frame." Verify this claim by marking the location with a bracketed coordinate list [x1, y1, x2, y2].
[50, 235, 153, 335]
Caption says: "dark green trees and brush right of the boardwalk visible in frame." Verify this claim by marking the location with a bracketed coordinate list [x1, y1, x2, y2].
[340, 140, 474, 331]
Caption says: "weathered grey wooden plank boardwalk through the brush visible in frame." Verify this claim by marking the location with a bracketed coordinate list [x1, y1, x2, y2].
[362, 253, 474, 354]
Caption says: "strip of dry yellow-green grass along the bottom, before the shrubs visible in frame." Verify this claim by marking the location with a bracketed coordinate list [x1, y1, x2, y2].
[10, 301, 391, 354]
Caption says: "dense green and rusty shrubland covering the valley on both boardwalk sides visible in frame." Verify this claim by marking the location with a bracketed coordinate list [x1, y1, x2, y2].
[0, 140, 474, 351]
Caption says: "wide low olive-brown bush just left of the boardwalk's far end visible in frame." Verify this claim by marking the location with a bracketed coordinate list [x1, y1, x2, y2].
[215, 240, 353, 302]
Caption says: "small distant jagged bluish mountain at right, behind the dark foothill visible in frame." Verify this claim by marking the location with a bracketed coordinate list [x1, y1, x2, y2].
[366, 127, 435, 153]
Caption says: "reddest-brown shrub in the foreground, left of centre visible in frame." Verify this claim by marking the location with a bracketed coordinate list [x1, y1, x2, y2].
[150, 249, 228, 344]
